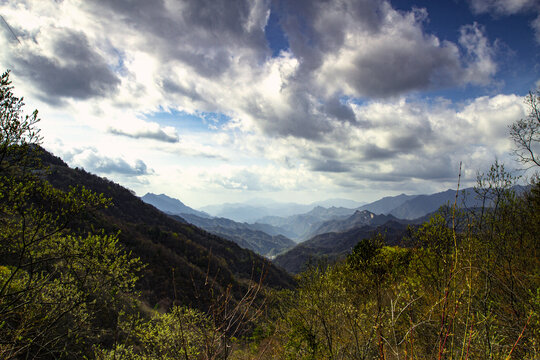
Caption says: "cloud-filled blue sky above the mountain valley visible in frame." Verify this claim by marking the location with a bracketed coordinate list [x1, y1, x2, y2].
[0, 0, 540, 208]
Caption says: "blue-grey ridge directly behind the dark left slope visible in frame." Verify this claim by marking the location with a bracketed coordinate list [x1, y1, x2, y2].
[173, 214, 295, 257]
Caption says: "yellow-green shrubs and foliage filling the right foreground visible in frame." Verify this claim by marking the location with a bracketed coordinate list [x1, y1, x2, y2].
[274, 171, 540, 359]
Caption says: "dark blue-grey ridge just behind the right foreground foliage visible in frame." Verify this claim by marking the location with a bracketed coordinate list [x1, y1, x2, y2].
[273, 221, 407, 274]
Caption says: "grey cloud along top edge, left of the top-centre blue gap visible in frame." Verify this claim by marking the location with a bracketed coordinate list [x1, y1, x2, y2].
[91, 0, 271, 78]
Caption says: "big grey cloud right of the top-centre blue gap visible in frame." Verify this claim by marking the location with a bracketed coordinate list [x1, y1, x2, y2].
[284, 1, 493, 97]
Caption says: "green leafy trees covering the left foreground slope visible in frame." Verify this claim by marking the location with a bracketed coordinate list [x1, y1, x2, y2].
[0, 72, 140, 359]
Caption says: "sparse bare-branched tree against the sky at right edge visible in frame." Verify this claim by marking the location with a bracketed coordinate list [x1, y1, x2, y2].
[510, 90, 540, 167]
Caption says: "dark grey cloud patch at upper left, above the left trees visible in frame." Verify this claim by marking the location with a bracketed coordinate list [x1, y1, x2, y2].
[13, 29, 120, 104]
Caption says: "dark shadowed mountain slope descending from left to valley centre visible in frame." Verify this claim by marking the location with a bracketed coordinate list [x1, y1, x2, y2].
[41, 151, 294, 309]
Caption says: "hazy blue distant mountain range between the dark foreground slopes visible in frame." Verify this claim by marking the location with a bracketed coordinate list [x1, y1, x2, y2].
[138, 181, 523, 273]
